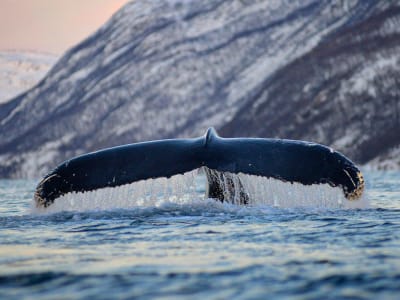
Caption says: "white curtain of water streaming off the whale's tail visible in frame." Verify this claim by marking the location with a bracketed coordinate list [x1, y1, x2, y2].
[32, 170, 368, 213]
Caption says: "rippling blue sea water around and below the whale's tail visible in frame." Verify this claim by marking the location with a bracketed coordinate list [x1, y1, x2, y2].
[0, 172, 400, 299]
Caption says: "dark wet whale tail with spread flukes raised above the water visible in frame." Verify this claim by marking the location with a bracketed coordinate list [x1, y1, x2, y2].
[34, 128, 364, 207]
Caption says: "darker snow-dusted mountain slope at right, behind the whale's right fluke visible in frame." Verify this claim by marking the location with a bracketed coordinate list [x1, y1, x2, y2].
[222, 7, 400, 167]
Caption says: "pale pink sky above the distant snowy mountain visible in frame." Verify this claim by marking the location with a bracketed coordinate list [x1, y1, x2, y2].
[0, 0, 128, 54]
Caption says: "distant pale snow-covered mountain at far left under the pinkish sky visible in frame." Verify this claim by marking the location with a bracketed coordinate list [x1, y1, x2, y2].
[0, 51, 57, 103]
